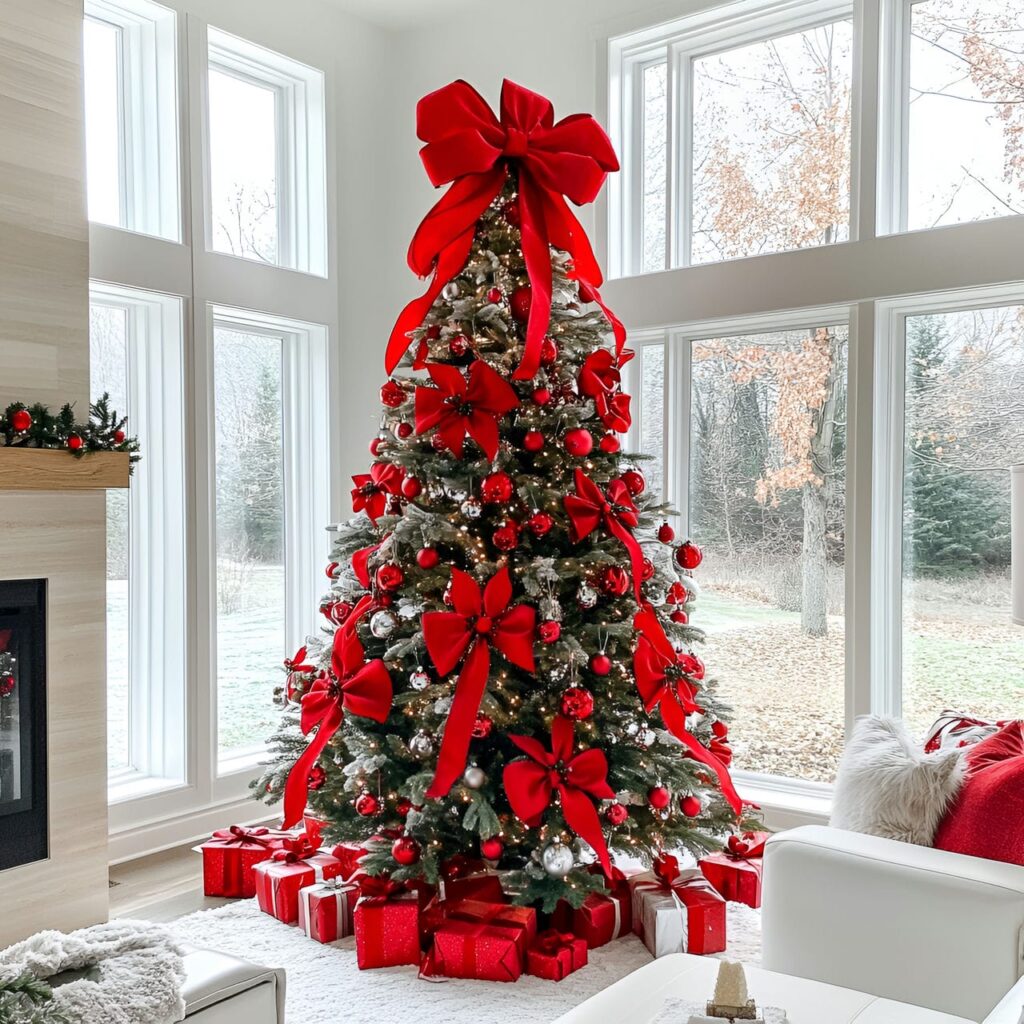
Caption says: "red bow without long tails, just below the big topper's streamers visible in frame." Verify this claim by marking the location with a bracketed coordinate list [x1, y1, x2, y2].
[416, 359, 519, 460]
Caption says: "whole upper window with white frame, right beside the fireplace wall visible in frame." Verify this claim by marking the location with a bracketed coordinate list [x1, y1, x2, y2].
[84, 0, 181, 241]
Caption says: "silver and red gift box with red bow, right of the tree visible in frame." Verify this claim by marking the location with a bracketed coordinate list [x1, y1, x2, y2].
[629, 854, 725, 956]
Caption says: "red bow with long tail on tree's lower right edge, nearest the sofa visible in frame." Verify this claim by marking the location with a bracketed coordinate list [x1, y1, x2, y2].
[633, 604, 743, 814]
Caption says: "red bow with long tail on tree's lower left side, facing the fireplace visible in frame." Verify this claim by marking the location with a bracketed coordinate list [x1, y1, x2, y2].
[285, 628, 391, 828]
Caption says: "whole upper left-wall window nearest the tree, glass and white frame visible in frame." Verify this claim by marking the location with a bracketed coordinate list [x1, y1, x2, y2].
[207, 29, 327, 275]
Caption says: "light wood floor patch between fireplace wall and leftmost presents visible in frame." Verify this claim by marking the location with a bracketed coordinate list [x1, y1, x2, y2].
[110, 846, 231, 922]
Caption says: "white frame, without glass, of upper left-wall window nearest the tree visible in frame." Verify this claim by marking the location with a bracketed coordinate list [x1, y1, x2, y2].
[202, 27, 328, 276]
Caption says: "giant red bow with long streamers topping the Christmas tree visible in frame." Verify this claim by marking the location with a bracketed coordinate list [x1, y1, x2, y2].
[385, 79, 626, 380]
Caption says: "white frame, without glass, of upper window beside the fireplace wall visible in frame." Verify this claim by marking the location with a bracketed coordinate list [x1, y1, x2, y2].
[85, 0, 181, 242]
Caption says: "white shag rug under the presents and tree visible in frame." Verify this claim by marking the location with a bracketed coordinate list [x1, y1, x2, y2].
[169, 900, 761, 1024]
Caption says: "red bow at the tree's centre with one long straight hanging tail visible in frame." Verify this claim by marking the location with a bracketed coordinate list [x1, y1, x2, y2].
[423, 566, 537, 799]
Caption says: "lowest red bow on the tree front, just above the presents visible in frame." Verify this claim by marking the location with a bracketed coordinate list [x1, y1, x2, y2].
[503, 715, 615, 874]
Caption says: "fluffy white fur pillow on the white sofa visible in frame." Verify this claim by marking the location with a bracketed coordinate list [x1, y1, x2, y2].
[829, 715, 964, 846]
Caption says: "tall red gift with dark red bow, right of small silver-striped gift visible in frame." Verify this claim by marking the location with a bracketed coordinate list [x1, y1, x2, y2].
[352, 876, 420, 971]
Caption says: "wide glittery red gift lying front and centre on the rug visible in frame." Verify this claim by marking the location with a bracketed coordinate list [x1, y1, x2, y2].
[422, 919, 525, 981]
